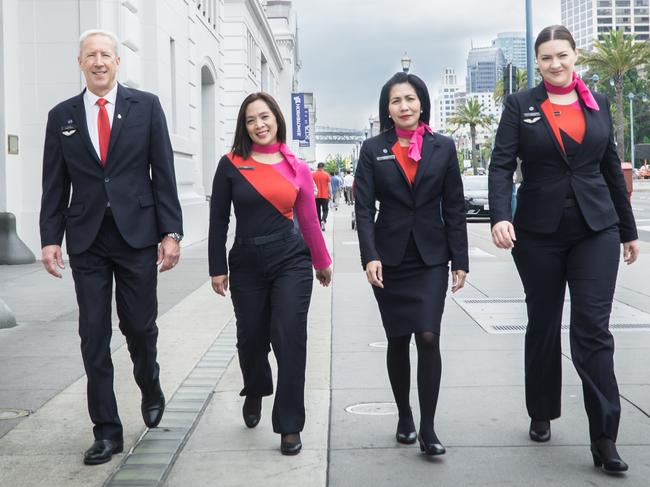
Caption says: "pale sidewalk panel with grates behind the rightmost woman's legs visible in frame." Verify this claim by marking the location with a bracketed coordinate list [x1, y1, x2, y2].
[454, 298, 650, 333]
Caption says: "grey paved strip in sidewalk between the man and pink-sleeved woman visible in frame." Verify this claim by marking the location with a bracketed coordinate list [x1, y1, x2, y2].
[104, 318, 236, 487]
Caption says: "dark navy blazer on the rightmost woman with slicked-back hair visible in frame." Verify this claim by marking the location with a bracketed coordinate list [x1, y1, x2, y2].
[489, 83, 638, 242]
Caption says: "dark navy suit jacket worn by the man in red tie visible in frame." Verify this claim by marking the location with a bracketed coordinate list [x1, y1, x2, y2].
[40, 85, 183, 254]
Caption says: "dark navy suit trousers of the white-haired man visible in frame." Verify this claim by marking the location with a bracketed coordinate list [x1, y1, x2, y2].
[70, 215, 159, 440]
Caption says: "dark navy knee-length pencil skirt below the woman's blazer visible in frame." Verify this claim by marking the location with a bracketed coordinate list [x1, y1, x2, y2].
[372, 236, 449, 337]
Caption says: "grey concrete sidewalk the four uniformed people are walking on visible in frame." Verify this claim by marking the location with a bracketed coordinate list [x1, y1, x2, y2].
[0, 204, 650, 487]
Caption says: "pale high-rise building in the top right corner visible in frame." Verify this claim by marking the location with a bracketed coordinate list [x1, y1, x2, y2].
[561, 0, 650, 50]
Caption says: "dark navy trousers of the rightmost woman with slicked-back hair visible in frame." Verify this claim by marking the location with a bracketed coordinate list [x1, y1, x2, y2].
[512, 206, 621, 441]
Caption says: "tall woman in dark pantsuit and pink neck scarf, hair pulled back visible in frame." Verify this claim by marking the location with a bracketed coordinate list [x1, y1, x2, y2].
[489, 26, 639, 472]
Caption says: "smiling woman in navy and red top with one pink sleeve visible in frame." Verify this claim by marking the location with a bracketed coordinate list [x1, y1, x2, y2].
[208, 93, 332, 455]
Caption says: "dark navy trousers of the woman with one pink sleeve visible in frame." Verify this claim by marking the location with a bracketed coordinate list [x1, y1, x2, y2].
[228, 232, 314, 434]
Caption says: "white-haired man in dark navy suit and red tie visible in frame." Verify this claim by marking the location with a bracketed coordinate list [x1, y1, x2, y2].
[40, 30, 183, 465]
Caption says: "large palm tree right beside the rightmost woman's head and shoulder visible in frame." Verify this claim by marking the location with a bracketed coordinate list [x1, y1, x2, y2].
[578, 30, 649, 161]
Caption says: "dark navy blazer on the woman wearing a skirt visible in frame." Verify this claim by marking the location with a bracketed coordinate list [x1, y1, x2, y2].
[354, 129, 469, 271]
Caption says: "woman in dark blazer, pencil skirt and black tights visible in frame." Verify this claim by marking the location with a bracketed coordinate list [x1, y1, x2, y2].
[354, 73, 469, 455]
